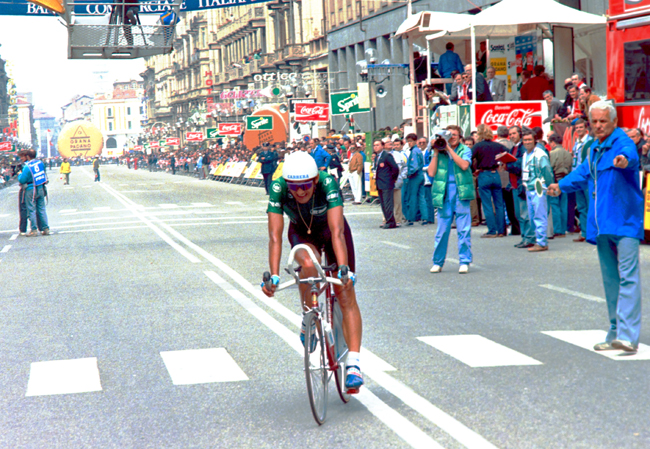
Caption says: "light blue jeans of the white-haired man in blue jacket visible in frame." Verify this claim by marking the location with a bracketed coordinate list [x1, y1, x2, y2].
[596, 235, 641, 345]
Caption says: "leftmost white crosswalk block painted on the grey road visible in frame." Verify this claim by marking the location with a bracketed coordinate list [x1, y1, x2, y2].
[25, 357, 102, 396]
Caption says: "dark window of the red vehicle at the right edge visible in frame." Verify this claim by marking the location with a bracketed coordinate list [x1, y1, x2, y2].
[624, 40, 650, 101]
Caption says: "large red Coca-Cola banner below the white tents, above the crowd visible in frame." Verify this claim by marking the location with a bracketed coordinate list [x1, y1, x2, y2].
[468, 101, 548, 131]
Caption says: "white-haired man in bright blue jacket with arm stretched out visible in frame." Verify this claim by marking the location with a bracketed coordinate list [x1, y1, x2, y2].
[548, 101, 643, 353]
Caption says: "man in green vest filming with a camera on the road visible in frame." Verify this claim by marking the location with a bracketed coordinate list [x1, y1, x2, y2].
[427, 125, 476, 274]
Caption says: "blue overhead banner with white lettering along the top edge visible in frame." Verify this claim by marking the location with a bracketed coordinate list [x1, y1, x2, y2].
[0, 0, 270, 16]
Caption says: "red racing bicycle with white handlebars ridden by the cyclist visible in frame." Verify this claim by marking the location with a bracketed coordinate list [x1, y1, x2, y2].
[263, 244, 358, 425]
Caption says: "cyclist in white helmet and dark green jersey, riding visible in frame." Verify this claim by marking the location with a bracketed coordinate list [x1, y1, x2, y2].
[262, 151, 363, 393]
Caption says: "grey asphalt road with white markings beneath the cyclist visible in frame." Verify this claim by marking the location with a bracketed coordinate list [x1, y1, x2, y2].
[0, 162, 650, 449]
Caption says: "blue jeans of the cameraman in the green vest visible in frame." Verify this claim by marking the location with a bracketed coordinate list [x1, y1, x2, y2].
[433, 182, 472, 267]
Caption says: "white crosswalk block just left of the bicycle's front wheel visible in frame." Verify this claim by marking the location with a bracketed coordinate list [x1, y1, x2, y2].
[160, 348, 248, 385]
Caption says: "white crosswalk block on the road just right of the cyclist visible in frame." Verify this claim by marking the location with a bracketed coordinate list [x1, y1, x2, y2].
[418, 335, 542, 368]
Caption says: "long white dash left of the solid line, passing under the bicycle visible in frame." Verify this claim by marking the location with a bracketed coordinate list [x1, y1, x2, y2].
[204, 271, 442, 448]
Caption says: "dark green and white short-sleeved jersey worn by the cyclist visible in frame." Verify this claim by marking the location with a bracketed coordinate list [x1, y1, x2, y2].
[266, 171, 343, 233]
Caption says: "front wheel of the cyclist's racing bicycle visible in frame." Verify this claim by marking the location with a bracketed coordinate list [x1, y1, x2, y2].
[303, 312, 329, 425]
